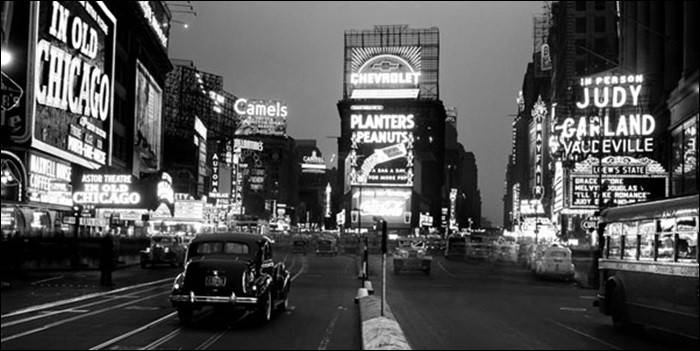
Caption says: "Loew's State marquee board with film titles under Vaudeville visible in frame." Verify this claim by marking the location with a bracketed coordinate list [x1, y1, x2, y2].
[569, 156, 668, 209]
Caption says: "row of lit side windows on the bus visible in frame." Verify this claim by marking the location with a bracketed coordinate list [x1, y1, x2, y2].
[605, 216, 698, 262]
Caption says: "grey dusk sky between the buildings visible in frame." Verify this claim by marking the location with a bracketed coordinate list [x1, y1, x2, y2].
[169, 1, 543, 225]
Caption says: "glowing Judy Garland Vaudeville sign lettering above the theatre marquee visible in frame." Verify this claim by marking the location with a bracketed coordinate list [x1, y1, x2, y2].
[555, 75, 656, 159]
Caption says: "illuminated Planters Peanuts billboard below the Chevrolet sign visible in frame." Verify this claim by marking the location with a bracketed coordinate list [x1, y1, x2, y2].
[348, 104, 416, 187]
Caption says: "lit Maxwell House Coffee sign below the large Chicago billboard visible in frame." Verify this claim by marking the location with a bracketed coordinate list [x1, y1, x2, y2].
[27, 153, 73, 206]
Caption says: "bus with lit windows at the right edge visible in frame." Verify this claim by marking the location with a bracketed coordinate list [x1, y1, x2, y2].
[594, 195, 700, 340]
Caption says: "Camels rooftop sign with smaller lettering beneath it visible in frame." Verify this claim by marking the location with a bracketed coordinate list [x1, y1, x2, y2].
[233, 98, 287, 136]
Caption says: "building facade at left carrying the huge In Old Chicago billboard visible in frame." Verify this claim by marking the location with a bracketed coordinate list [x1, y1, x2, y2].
[0, 1, 172, 236]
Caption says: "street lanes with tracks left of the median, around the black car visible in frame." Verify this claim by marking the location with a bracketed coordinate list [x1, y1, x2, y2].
[2, 252, 361, 350]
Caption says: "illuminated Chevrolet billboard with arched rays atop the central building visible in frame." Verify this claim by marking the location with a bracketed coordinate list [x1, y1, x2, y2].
[346, 46, 422, 99]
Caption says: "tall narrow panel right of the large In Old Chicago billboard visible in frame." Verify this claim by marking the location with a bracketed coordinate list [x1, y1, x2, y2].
[133, 59, 163, 177]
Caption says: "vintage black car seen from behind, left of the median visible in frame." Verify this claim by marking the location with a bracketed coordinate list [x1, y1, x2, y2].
[170, 233, 291, 324]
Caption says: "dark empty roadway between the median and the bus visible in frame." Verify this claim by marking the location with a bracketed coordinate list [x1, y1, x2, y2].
[370, 255, 688, 350]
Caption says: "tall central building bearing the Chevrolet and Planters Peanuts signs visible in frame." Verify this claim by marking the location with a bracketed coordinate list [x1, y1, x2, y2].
[337, 25, 446, 233]
